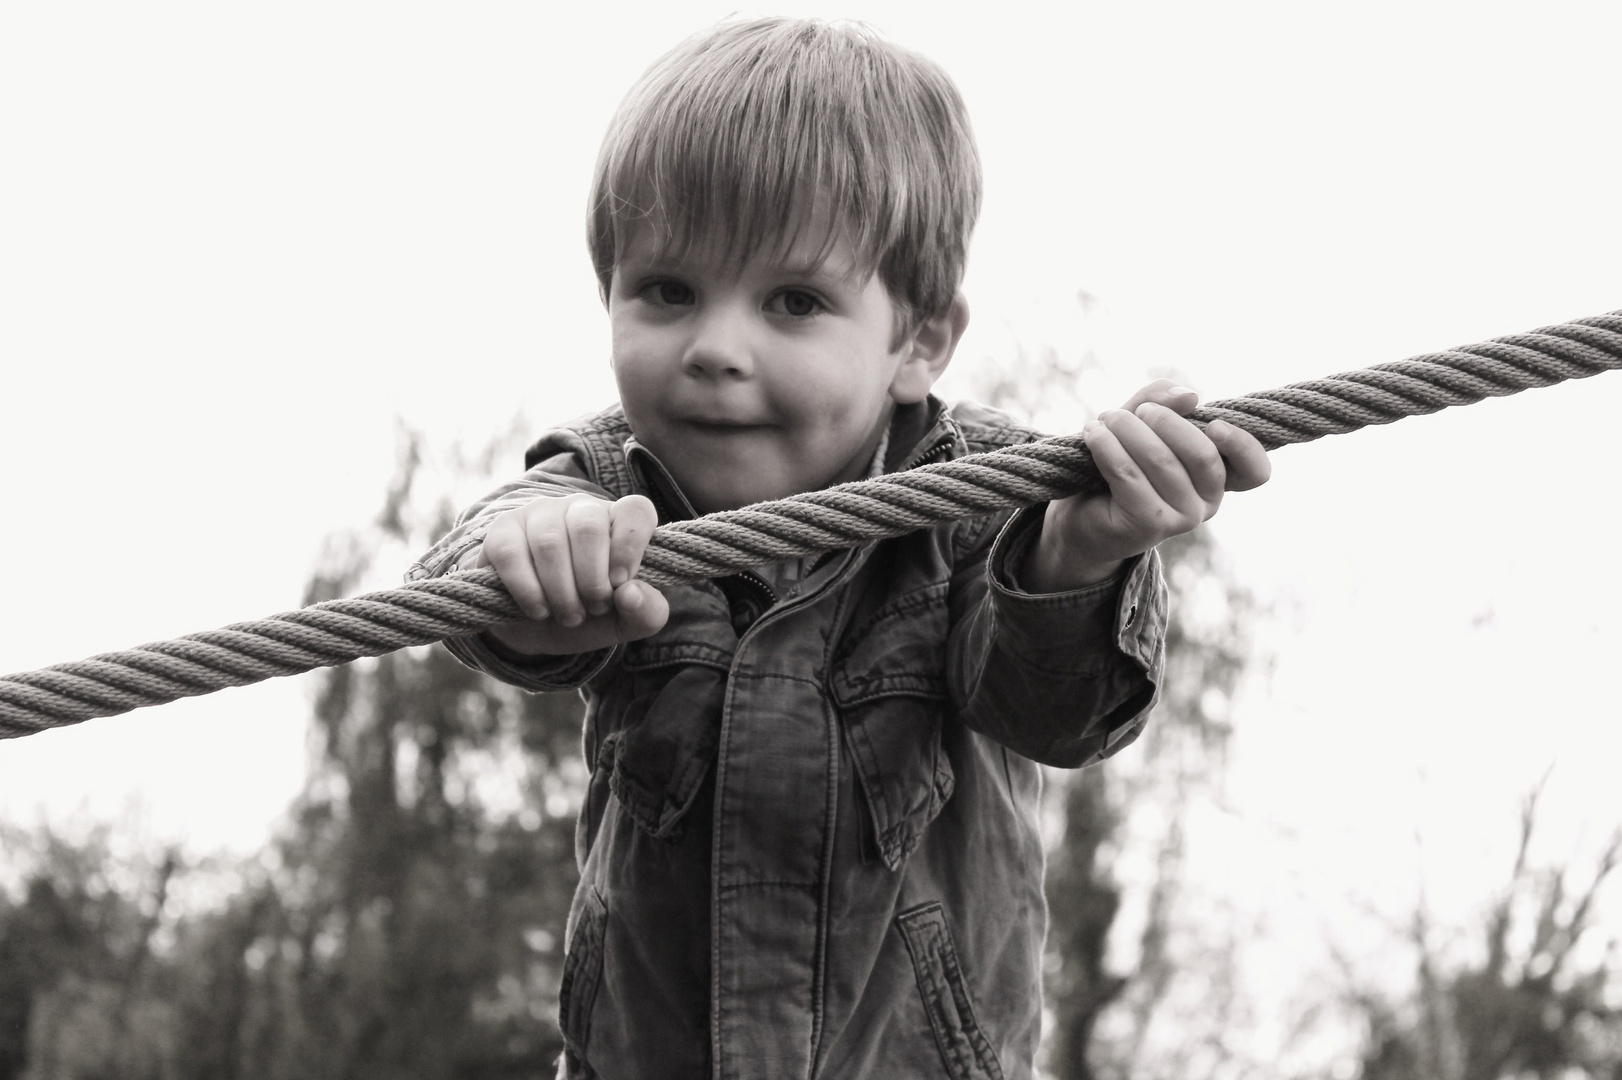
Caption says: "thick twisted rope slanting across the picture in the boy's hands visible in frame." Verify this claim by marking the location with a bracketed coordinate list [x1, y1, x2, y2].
[0, 311, 1622, 738]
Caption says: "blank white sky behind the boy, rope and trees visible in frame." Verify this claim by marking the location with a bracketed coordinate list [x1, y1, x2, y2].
[0, 0, 1622, 1044]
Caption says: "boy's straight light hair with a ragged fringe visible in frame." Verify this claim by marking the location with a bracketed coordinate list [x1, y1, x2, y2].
[587, 18, 980, 336]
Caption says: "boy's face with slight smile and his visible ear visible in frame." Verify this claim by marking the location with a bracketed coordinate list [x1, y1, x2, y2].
[608, 222, 967, 514]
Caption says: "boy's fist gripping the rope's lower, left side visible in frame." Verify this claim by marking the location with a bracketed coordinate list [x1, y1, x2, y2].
[474, 495, 670, 655]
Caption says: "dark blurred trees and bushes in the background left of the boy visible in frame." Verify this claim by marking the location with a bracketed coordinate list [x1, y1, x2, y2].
[0, 436, 586, 1080]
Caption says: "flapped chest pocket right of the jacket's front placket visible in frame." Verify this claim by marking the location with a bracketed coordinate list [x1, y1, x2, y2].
[829, 582, 952, 869]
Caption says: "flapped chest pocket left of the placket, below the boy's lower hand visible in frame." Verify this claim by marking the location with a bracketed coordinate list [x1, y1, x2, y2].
[594, 587, 736, 840]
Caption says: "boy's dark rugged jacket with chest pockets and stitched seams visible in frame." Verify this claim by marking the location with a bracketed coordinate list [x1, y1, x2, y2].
[412, 397, 1166, 1080]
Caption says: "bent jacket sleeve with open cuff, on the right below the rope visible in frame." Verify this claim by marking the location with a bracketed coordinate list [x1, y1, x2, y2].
[947, 506, 1168, 769]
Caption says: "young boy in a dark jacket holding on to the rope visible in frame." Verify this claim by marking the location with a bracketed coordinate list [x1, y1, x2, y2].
[414, 19, 1268, 1080]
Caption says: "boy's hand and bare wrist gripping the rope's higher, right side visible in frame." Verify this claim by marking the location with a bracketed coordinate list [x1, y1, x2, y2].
[1020, 379, 1272, 592]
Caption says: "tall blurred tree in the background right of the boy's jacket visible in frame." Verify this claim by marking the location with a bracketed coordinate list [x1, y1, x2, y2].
[970, 321, 1257, 1080]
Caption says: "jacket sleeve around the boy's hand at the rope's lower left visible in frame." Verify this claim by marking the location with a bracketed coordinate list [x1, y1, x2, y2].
[406, 433, 616, 692]
